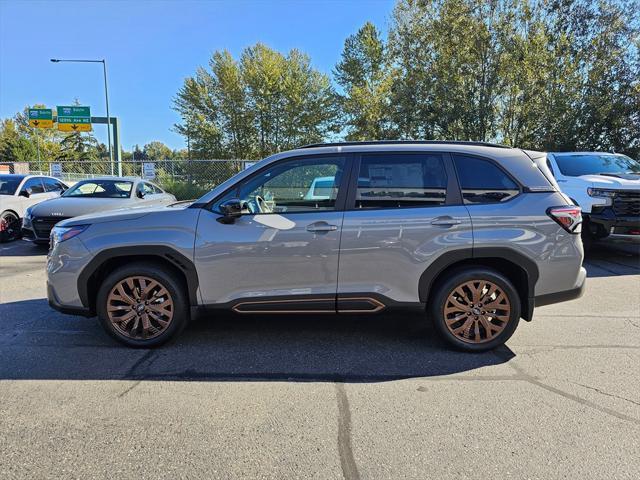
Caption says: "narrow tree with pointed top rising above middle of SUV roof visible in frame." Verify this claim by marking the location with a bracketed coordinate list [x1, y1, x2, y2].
[334, 22, 394, 140]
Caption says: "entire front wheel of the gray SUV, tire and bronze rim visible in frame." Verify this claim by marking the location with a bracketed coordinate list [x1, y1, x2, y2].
[97, 263, 188, 348]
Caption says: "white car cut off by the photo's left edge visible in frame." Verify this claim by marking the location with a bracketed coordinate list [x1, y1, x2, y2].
[0, 174, 69, 241]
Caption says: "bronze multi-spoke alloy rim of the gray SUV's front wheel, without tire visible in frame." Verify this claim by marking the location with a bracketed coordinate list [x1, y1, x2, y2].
[107, 276, 174, 340]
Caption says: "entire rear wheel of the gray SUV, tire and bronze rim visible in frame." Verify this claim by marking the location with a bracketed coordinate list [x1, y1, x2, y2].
[430, 267, 520, 352]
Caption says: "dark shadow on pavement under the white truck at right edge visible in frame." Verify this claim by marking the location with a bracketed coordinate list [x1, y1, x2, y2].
[584, 239, 640, 278]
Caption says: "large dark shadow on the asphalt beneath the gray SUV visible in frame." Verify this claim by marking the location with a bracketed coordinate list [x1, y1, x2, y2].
[0, 299, 515, 382]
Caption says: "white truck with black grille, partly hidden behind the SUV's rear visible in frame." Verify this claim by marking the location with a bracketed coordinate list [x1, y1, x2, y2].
[547, 152, 640, 241]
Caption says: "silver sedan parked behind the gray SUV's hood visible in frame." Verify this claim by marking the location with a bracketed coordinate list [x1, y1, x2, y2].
[22, 177, 176, 244]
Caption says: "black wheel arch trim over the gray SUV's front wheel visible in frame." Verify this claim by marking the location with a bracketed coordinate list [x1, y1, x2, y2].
[78, 245, 199, 308]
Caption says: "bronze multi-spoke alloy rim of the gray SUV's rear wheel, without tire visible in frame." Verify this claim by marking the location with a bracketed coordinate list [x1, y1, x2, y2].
[444, 280, 511, 344]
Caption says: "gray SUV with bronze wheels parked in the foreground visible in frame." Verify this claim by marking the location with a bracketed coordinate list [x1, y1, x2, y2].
[47, 141, 586, 351]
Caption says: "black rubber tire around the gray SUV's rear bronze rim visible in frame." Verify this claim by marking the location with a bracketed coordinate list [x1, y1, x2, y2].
[428, 267, 521, 352]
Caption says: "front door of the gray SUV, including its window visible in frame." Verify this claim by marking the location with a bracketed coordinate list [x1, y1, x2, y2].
[195, 155, 348, 313]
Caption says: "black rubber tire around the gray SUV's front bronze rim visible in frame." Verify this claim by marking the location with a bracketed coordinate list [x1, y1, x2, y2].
[96, 263, 189, 348]
